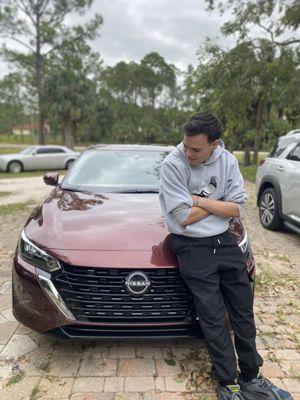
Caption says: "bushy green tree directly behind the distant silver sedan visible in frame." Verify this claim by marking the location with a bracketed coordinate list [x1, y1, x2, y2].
[43, 39, 101, 148]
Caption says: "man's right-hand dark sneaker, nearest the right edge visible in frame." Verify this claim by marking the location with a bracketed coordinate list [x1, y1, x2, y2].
[238, 374, 293, 400]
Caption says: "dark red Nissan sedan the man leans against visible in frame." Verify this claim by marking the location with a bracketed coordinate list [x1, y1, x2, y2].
[13, 145, 255, 338]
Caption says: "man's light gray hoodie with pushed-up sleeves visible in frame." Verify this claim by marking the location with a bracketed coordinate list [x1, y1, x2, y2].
[159, 139, 246, 237]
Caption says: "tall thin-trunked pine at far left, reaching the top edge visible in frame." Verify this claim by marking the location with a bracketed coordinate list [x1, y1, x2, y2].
[0, 0, 102, 144]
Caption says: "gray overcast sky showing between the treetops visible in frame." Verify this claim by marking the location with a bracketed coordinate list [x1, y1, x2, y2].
[0, 0, 230, 75]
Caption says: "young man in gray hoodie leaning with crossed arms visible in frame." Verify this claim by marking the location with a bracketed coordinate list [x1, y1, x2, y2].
[160, 112, 292, 400]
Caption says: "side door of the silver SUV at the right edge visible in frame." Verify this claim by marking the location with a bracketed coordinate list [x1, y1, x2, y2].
[282, 143, 300, 223]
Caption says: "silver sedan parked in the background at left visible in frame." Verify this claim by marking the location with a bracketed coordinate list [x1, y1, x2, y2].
[0, 145, 79, 173]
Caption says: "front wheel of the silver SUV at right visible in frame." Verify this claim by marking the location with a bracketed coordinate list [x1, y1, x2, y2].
[259, 188, 282, 231]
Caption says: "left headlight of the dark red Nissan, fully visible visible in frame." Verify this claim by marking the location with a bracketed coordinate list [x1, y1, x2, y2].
[19, 230, 61, 272]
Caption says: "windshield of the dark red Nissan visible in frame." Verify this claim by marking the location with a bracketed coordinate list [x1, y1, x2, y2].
[61, 148, 168, 193]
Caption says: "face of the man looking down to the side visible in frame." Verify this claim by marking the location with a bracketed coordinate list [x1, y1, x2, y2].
[183, 133, 219, 165]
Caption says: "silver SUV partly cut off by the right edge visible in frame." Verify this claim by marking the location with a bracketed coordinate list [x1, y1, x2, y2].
[256, 130, 300, 233]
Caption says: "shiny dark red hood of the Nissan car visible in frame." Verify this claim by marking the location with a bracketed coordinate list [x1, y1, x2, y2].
[25, 188, 176, 265]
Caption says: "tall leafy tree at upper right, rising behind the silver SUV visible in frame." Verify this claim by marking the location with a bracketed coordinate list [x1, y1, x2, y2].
[202, 0, 300, 163]
